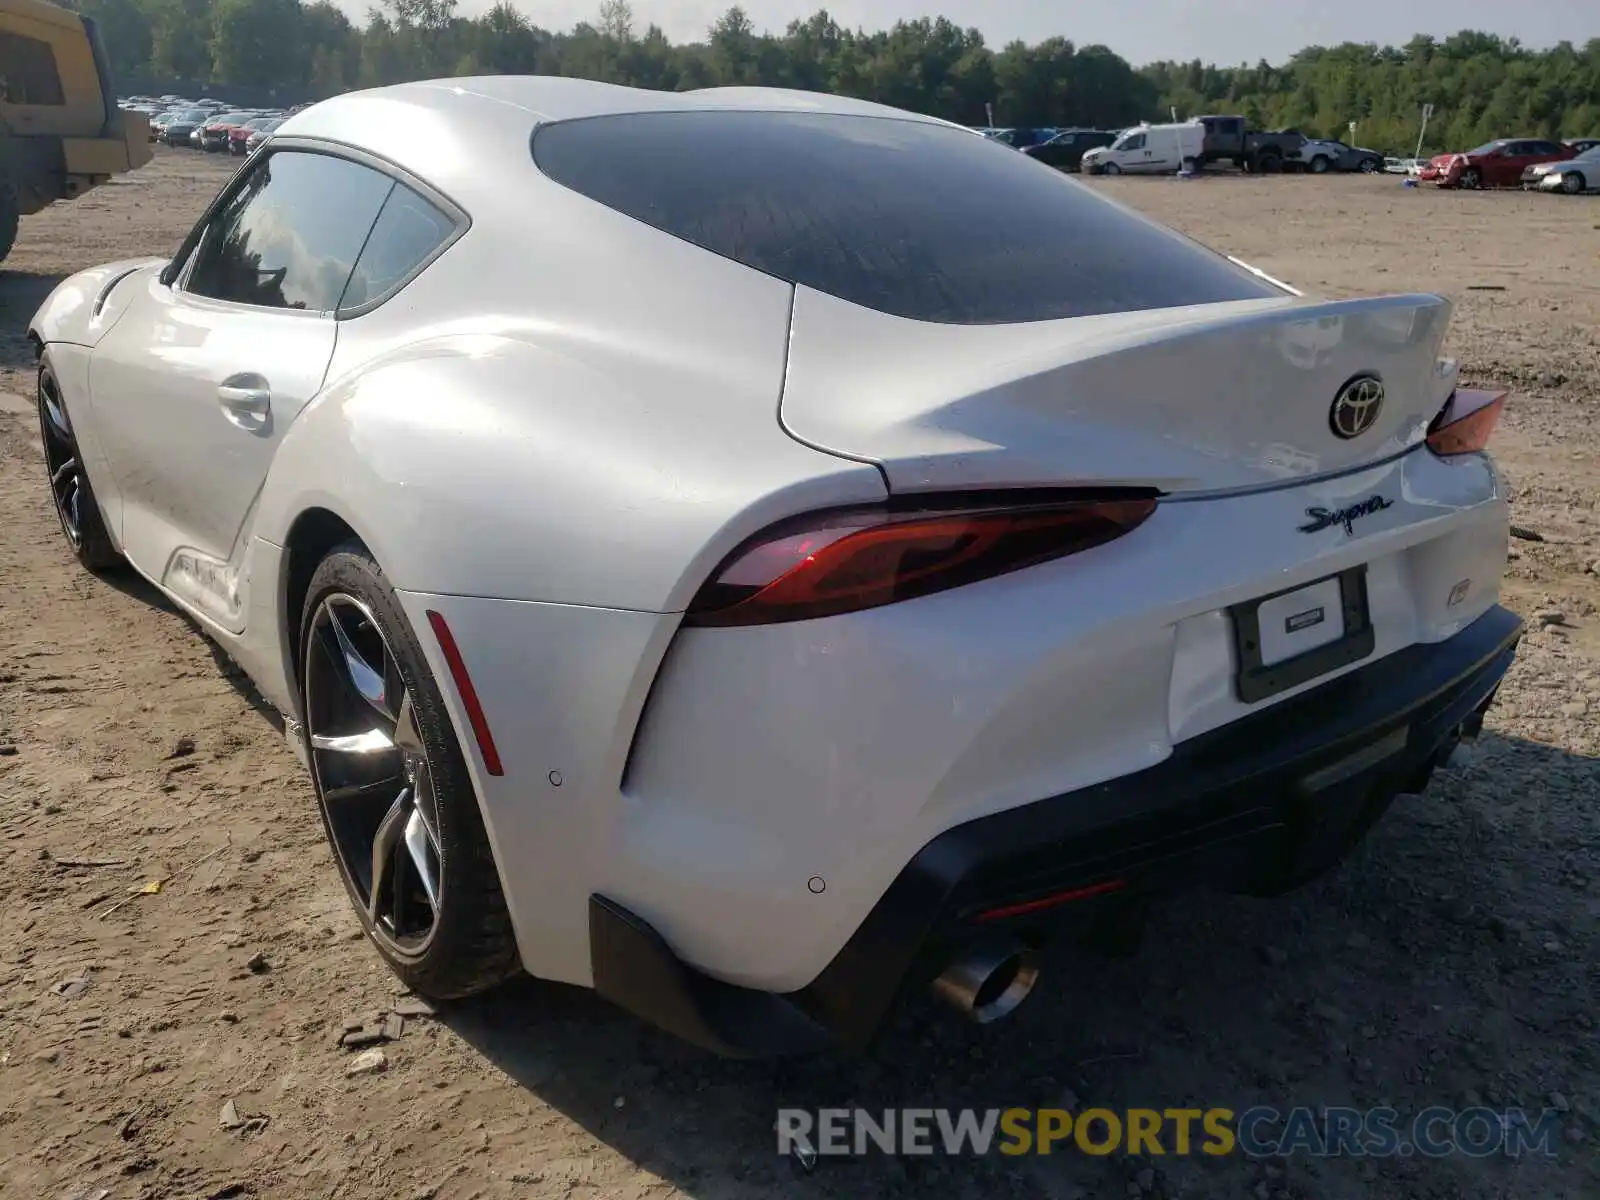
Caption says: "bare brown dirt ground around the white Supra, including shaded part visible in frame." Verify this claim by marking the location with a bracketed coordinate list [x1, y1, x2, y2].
[0, 152, 1600, 1200]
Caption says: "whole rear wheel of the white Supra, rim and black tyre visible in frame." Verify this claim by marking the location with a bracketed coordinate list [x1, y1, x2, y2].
[299, 542, 518, 1000]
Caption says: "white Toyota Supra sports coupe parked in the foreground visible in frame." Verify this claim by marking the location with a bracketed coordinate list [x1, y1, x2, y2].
[30, 77, 1522, 1054]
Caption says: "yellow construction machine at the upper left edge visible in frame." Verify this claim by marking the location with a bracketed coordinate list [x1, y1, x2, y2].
[0, 0, 150, 259]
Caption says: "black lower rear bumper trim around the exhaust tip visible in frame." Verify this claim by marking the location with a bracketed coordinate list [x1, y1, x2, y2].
[589, 606, 1522, 1056]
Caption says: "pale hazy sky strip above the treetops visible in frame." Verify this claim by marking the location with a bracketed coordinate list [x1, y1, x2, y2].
[356, 0, 1600, 66]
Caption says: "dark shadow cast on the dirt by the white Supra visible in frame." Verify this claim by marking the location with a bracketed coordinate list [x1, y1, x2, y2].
[443, 733, 1600, 1200]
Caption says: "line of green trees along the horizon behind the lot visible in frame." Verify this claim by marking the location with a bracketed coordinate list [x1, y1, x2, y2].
[75, 0, 1600, 154]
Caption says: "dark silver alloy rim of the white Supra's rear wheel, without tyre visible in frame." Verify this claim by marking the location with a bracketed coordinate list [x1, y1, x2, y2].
[302, 592, 443, 955]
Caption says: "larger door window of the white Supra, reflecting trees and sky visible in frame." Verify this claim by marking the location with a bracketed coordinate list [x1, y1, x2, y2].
[186, 150, 395, 312]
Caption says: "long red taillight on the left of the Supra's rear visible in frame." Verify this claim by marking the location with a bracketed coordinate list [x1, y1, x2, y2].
[685, 491, 1157, 626]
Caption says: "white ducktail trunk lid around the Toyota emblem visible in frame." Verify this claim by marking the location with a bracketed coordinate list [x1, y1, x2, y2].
[779, 286, 1454, 493]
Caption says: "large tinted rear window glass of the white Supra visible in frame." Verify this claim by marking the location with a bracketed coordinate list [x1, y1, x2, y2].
[533, 110, 1283, 325]
